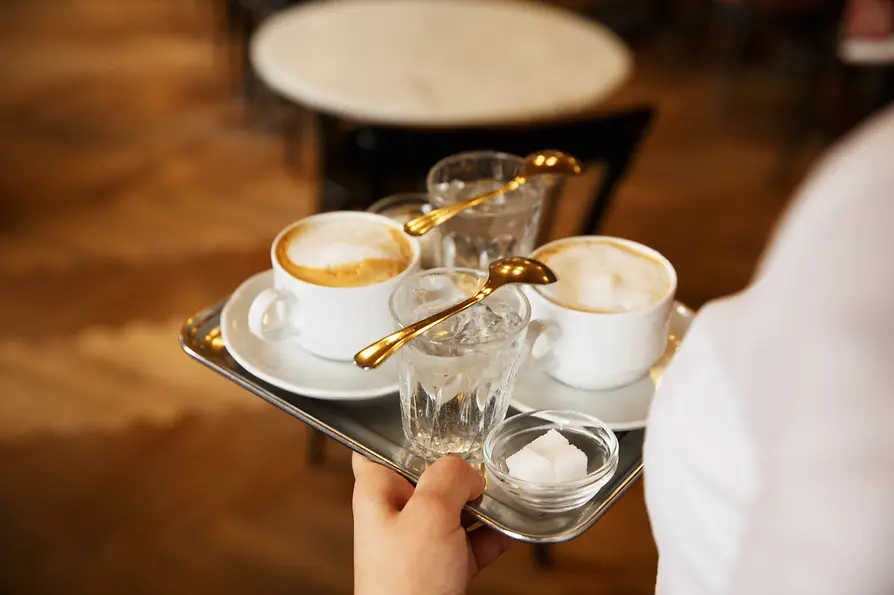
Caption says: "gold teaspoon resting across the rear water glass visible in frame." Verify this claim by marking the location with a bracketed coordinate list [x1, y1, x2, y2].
[404, 151, 581, 237]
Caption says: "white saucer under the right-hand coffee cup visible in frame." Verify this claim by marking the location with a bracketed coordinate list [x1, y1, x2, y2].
[512, 302, 695, 431]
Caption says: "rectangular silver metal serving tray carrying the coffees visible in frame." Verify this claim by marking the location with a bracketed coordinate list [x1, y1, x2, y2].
[180, 300, 645, 543]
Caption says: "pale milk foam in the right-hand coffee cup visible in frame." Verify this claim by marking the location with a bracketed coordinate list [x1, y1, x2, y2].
[534, 240, 672, 314]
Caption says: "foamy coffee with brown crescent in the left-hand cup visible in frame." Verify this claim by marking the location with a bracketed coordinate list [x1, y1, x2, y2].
[274, 219, 413, 287]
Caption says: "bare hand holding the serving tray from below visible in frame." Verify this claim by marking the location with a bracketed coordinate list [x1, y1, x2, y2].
[352, 453, 512, 595]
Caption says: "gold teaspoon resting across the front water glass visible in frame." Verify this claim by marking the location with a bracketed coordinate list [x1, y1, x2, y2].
[354, 256, 556, 370]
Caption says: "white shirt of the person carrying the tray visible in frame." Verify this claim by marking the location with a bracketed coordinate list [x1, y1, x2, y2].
[645, 110, 894, 595]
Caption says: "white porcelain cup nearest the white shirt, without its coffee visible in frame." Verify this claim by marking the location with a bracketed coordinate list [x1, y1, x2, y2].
[525, 236, 677, 390]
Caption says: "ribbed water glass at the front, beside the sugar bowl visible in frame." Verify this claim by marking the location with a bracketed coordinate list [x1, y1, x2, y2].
[391, 268, 536, 459]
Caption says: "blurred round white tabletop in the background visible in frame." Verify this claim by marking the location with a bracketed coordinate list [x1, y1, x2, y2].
[251, 0, 632, 127]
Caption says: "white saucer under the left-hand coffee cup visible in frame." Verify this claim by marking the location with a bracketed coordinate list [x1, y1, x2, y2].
[220, 270, 398, 401]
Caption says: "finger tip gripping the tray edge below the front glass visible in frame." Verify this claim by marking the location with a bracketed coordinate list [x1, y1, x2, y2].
[411, 456, 484, 521]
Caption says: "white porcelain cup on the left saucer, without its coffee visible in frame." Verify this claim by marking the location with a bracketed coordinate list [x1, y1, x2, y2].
[248, 211, 420, 361]
